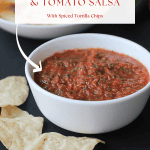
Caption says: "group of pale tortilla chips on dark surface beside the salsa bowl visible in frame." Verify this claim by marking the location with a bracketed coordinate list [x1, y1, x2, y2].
[0, 76, 104, 150]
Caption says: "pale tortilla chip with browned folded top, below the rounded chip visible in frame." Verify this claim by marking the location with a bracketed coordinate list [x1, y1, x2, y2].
[0, 106, 43, 150]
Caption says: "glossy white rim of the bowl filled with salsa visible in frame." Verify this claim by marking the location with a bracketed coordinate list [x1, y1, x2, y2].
[25, 33, 150, 106]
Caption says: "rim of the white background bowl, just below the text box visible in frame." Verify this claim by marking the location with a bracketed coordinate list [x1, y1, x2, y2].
[0, 18, 79, 29]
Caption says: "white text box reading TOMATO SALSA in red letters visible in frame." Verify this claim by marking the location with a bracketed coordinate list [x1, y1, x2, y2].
[15, 0, 135, 24]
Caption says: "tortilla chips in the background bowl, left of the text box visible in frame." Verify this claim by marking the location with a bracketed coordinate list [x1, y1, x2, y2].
[0, 0, 15, 22]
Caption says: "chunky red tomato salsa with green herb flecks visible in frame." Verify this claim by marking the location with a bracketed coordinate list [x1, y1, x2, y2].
[34, 48, 149, 101]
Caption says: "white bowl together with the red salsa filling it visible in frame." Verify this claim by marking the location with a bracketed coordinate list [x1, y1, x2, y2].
[25, 34, 150, 134]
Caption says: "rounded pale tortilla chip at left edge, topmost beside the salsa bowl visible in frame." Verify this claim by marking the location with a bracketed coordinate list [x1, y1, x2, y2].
[0, 76, 29, 107]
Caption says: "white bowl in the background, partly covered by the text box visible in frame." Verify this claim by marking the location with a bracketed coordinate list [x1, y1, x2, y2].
[0, 18, 92, 39]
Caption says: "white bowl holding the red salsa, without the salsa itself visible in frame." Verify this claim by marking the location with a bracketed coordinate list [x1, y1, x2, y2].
[25, 34, 150, 134]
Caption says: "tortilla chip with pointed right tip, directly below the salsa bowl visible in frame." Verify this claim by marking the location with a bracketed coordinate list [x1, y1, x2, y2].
[25, 132, 104, 150]
